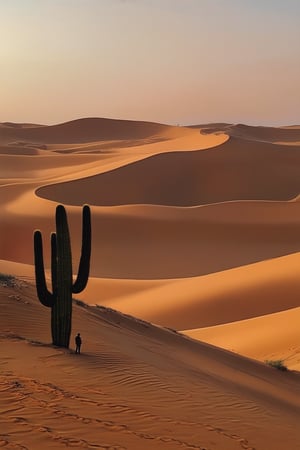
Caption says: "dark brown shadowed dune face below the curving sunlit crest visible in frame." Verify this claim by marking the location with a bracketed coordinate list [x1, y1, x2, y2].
[37, 138, 300, 206]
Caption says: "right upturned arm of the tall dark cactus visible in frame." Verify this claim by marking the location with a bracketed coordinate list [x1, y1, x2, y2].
[72, 205, 91, 294]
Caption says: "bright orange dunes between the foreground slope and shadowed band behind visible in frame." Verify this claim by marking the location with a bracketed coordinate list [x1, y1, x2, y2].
[0, 250, 300, 376]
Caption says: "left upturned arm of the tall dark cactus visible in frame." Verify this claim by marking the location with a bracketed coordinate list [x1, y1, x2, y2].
[34, 230, 55, 308]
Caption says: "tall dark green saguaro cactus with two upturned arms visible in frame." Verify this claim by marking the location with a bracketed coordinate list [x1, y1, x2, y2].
[34, 205, 91, 348]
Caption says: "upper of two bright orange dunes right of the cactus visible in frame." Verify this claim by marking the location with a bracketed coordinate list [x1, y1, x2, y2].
[80, 254, 300, 330]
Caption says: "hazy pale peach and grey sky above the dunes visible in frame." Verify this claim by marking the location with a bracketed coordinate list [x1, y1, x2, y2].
[0, 0, 300, 125]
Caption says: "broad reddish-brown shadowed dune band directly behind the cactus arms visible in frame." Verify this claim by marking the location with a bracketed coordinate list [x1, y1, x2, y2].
[0, 200, 300, 279]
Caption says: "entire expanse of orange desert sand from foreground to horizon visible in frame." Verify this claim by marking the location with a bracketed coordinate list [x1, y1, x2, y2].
[0, 118, 300, 450]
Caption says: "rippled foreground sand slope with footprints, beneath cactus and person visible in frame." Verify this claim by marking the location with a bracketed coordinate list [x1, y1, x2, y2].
[0, 284, 300, 450]
